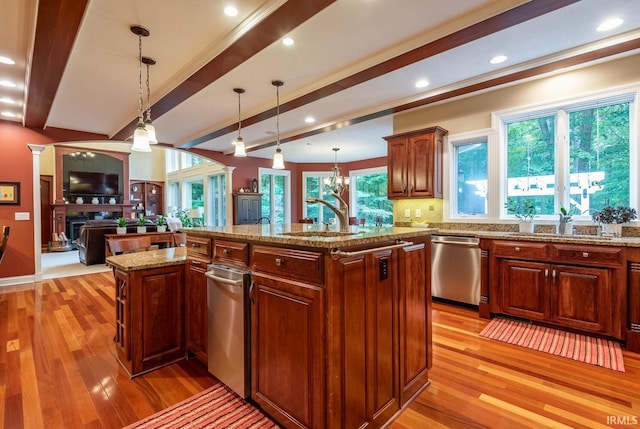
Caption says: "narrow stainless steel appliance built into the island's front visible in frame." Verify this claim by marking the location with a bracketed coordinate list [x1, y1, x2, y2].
[205, 264, 251, 398]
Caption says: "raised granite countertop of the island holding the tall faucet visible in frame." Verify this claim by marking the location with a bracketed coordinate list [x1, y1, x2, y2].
[181, 223, 437, 249]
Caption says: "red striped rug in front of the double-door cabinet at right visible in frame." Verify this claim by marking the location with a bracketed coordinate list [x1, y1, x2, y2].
[480, 318, 624, 372]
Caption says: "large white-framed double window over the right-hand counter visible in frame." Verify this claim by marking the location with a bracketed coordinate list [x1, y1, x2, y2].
[502, 94, 637, 219]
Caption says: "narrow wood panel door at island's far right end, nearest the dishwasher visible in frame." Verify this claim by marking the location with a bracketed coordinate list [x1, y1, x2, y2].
[398, 243, 431, 406]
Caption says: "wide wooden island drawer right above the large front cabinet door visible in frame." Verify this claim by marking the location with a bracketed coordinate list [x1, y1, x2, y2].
[251, 245, 322, 283]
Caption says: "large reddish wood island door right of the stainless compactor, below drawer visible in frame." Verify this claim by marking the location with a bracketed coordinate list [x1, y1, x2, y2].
[251, 274, 325, 428]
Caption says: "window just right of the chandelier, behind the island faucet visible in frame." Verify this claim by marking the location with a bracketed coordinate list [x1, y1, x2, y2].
[349, 167, 393, 226]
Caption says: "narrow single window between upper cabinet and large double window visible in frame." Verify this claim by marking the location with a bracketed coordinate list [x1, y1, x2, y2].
[452, 139, 489, 216]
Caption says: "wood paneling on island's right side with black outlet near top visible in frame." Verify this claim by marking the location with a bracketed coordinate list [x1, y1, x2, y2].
[327, 250, 400, 428]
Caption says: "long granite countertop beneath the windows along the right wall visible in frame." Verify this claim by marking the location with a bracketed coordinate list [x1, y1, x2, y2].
[432, 229, 640, 247]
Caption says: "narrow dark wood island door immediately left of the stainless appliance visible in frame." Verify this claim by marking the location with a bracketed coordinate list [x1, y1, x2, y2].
[185, 259, 208, 364]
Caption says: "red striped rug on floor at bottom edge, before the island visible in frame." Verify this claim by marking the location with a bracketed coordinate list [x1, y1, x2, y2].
[125, 384, 279, 429]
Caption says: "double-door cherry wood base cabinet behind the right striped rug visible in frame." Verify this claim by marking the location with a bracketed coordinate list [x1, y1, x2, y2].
[491, 240, 626, 339]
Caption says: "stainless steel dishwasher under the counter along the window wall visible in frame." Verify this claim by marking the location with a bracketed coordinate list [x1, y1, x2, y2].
[431, 235, 480, 305]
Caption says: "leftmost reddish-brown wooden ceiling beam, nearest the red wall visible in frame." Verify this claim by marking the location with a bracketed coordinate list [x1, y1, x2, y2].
[23, 0, 88, 129]
